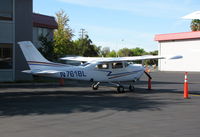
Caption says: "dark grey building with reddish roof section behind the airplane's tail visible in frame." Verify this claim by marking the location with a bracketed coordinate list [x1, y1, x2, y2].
[0, 0, 57, 82]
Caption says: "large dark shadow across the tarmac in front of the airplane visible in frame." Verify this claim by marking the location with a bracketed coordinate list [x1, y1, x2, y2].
[0, 89, 183, 116]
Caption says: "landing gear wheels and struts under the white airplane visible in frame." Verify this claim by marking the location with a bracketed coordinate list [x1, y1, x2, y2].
[92, 82, 135, 93]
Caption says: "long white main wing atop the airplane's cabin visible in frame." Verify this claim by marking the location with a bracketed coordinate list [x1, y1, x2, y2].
[61, 55, 182, 62]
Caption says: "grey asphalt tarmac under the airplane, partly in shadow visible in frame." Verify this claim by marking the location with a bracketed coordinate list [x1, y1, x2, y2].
[0, 72, 200, 137]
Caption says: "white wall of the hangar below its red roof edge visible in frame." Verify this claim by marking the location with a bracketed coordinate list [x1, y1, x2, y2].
[159, 39, 200, 72]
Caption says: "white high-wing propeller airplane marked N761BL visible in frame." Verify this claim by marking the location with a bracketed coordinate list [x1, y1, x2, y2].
[18, 41, 182, 93]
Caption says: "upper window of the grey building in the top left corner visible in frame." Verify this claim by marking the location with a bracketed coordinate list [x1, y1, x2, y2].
[0, 0, 13, 20]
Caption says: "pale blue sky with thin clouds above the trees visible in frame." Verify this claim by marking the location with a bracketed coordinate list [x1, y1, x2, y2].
[33, 0, 200, 51]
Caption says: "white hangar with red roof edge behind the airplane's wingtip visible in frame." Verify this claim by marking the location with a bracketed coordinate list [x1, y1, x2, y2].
[155, 31, 200, 72]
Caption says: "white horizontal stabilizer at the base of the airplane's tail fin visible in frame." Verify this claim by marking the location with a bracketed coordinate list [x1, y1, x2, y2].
[22, 70, 62, 75]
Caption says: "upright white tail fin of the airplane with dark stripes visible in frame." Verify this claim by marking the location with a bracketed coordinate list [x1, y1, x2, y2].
[18, 41, 50, 70]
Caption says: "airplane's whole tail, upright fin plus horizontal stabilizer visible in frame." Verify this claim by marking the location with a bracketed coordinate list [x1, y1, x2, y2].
[18, 41, 69, 77]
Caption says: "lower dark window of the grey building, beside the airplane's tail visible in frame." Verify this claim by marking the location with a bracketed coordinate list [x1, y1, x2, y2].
[0, 44, 12, 69]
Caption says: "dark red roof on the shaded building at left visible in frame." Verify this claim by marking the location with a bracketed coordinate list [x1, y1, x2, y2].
[33, 13, 58, 29]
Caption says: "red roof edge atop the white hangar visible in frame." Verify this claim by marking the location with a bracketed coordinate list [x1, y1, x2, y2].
[154, 31, 200, 41]
